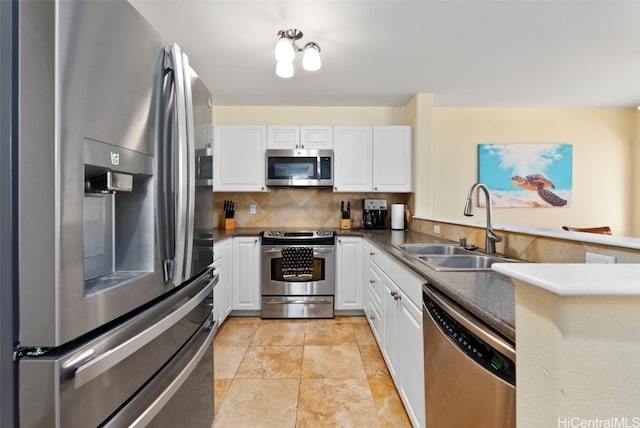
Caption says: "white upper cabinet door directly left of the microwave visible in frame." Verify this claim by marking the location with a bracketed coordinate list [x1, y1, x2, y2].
[213, 125, 267, 192]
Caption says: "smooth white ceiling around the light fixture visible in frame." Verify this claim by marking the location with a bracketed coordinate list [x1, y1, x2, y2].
[130, 0, 640, 108]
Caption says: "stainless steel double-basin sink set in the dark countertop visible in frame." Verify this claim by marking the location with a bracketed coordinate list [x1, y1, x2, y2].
[398, 244, 517, 271]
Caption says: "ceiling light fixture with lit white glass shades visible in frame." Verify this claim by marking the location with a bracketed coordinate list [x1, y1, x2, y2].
[276, 28, 322, 79]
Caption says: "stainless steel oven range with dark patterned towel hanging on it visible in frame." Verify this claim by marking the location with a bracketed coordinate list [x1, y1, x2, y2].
[261, 230, 336, 318]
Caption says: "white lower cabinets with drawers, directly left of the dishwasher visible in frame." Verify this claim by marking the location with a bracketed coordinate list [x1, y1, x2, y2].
[363, 240, 426, 427]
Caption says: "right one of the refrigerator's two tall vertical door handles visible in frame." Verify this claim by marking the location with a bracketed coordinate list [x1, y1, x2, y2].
[182, 53, 196, 280]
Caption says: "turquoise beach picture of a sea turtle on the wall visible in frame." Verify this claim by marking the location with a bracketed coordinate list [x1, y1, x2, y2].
[478, 144, 573, 208]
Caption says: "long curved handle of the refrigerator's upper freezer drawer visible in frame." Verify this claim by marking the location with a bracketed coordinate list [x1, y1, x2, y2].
[75, 281, 213, 389]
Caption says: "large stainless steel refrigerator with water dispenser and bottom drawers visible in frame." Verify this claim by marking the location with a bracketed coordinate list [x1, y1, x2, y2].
[14, 0, 217, 427]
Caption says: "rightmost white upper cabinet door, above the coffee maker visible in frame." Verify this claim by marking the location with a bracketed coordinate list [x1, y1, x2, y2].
[373, 126, 411, 192]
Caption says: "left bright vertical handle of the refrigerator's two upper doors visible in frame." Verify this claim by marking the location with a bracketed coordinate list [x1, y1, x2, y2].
[171, 44, 188, 286]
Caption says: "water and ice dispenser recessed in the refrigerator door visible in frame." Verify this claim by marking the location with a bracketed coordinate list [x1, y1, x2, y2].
[83, 139, 155, 295]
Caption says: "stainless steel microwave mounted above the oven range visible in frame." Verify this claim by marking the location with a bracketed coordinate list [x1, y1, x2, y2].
[265, 149, 333, 187]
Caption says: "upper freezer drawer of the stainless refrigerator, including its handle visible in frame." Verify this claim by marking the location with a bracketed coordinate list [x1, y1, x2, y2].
[18, 272, 217, 427]
